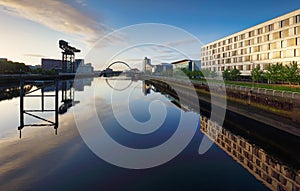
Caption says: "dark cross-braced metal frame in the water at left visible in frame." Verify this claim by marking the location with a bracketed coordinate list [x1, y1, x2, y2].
[18, 79, 59, 138]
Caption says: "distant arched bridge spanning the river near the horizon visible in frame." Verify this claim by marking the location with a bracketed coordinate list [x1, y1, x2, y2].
[100, 61, 131, 77]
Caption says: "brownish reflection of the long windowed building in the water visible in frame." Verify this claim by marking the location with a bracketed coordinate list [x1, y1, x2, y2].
[200, 116, 300, 191]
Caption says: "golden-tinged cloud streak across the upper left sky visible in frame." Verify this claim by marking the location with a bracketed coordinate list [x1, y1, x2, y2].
[0, 0, 110, 44]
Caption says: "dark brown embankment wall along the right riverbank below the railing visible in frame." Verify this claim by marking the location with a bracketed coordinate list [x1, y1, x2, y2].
[148, 78, 300, 136]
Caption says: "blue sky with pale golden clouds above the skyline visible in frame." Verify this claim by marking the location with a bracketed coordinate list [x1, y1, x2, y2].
[0, 0, 300, 69]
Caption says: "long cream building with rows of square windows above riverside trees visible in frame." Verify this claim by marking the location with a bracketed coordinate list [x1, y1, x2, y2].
[201, 9, 300, 76]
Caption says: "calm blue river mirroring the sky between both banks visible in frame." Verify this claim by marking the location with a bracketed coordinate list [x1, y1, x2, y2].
[0, 78, 300, 191]
